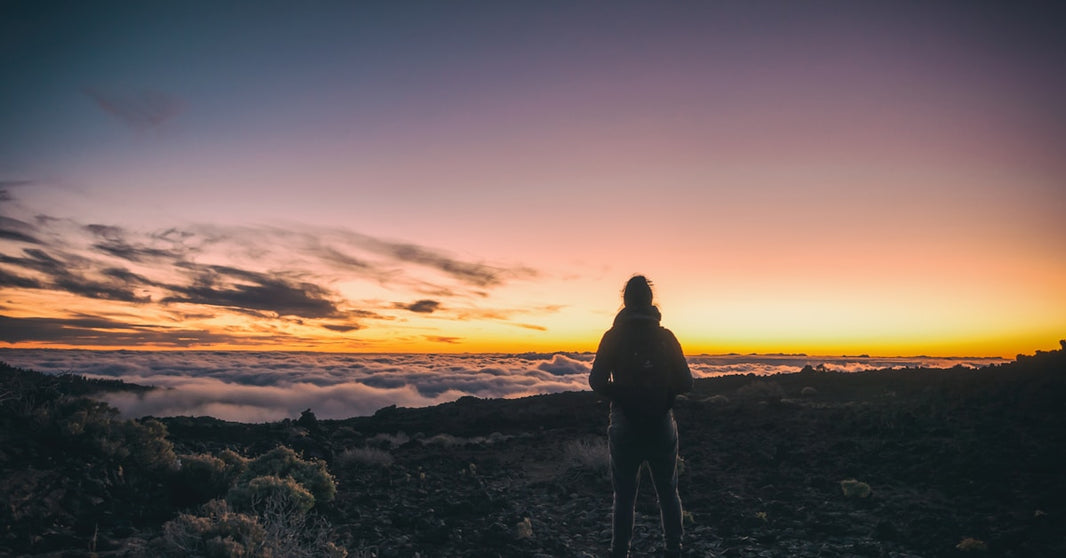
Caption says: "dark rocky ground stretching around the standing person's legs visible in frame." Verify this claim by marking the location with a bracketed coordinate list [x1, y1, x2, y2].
[0, 351, 1066, 558]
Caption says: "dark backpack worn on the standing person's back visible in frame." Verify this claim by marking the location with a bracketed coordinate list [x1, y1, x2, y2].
[613, 325, 675, 420]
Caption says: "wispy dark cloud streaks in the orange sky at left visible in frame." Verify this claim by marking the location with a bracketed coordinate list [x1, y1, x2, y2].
[0, 194, 552, 346]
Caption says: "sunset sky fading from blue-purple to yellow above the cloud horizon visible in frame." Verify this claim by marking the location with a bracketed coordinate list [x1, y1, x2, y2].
[0, 1, 1066, 356]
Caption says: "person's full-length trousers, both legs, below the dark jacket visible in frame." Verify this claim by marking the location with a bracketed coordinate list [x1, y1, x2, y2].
[608, 409, 683, 556]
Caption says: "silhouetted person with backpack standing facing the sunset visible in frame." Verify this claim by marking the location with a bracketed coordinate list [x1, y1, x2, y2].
[588, 275, 692, 558]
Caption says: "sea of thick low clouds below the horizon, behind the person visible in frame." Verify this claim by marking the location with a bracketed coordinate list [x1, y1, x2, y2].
[0, 349, 1004, 423]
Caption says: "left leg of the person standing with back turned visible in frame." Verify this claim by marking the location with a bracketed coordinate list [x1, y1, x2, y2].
[608, 415, 642, 558]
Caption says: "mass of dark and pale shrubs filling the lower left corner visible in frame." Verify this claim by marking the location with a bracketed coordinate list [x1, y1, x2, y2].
[0, 363, 343, 557]
